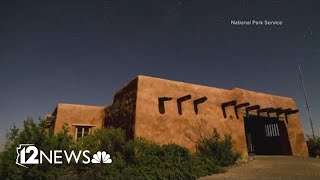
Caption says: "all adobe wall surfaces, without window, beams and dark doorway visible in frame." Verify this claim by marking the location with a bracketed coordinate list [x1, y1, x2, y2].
[54, 76, 308, 157]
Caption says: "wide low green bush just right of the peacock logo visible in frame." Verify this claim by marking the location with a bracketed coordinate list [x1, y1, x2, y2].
[120, 142, 196, 179]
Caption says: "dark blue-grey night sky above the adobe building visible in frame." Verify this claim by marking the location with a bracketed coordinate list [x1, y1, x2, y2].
[0, 0, 320, 147]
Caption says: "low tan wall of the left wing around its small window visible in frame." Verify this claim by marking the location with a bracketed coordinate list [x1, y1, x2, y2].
[54, 103, 106, 137]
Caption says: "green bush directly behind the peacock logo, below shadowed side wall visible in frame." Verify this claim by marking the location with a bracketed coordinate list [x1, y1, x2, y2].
[73, 128, 126, 179]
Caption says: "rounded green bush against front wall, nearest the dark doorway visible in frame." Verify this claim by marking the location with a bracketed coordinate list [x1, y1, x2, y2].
[196, 129, 240, 166]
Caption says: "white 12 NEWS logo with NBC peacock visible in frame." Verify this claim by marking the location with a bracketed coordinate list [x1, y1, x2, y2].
[16, 144, 112, 168]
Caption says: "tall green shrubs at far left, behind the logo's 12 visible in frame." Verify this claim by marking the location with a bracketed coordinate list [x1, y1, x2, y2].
[0, 118, 73, 179]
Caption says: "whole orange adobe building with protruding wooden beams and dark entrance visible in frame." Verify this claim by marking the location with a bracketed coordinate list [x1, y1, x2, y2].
[46, 76, 308, 157]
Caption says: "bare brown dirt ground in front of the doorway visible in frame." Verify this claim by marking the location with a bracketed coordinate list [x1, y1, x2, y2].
[200, 156, 320, 180]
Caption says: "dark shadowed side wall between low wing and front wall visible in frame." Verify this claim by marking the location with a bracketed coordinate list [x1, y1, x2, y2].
[105, 78, 138, 138]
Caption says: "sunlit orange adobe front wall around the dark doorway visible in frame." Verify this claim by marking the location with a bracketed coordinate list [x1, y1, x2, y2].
[135, 76, 307, 157]
